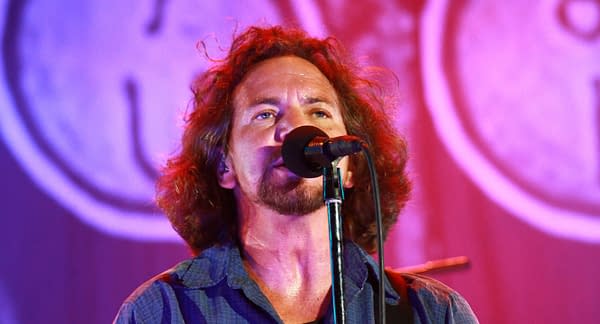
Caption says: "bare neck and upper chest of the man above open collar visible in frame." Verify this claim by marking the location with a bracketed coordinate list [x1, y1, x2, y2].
[239, 208, 331, 320]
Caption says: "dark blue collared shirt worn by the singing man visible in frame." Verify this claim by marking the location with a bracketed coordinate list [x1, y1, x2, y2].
[115, 242, 477, 323]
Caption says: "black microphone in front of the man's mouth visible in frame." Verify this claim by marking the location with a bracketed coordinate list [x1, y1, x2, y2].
[281, 126, 367, 178]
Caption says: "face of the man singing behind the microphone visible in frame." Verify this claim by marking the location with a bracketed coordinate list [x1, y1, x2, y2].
[221, 56, 351, 215]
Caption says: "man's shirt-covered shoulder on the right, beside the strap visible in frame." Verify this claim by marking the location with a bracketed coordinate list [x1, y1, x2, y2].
[387, 271, 478, 323]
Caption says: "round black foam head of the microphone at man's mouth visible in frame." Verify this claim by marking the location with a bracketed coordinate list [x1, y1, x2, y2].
[281, 126, 329, 178]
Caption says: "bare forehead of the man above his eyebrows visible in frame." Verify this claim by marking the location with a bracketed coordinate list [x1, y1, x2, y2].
[234, 56, 337, 98]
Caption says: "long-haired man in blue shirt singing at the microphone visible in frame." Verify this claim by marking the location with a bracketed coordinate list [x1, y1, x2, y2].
[115, 27, 476, 323]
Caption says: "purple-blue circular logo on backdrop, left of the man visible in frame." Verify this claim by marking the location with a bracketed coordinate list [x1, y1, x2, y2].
[0, 0, 319, 240]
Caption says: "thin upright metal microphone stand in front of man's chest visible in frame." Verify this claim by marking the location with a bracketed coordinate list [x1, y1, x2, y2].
[323, 163, 346, 324]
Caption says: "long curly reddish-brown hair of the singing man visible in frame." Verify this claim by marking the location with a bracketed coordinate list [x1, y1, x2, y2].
[156, 26, 410, 254]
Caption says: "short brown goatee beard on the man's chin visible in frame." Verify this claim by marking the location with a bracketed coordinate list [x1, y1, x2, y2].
[258, 168, 324, 215]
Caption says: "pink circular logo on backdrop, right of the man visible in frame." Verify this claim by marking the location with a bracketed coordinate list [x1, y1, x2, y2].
[420, 0, 600, 243]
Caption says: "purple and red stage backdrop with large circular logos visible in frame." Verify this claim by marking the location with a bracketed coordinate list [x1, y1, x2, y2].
[0, 0, 600, 324]
